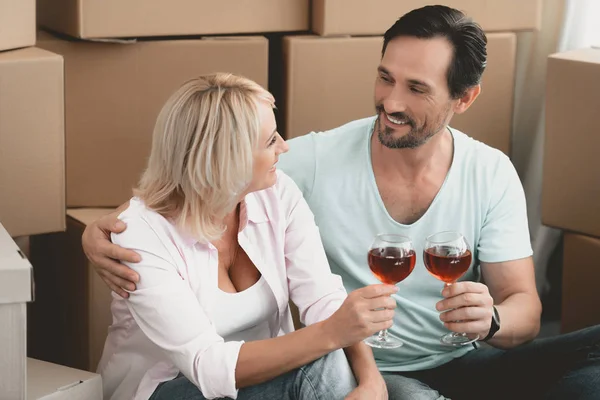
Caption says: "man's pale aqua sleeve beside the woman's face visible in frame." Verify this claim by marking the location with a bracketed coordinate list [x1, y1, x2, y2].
[277, 133, 317, 199]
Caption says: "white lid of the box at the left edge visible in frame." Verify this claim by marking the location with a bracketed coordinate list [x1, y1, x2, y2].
[0, 224, 33, 304]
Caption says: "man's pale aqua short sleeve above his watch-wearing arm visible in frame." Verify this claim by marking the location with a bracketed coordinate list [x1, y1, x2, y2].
[477, 155, 533, 263]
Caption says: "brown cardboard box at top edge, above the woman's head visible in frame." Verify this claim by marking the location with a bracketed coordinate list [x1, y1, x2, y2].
[38, 0, 310, 39]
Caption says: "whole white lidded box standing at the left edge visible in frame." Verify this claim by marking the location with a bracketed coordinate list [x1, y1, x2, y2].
[0, 224, 33, 399]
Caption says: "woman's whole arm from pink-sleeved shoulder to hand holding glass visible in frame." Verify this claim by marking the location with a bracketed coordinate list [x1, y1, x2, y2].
[119, 217, 396, 398]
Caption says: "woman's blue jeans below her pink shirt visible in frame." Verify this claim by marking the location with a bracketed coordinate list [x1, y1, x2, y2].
[149, 350, 356, 400]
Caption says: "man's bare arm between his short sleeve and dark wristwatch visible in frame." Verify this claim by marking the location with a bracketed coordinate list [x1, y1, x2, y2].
[481, 257, 542, 349]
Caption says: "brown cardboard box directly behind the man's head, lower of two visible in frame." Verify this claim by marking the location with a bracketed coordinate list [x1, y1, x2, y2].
[283, 33, 516, 153]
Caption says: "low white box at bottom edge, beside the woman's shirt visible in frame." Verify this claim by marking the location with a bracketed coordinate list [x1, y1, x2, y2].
[27, 358, 102, 400]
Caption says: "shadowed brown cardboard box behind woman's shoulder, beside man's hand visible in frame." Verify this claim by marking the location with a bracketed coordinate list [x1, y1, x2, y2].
[28, 209, 112, 371]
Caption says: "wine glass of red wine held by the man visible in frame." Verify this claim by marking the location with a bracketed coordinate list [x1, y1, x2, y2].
[423, 231, 479, 347]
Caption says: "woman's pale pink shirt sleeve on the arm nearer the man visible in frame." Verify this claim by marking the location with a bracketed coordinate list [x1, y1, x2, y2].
[278, 174, 347, 325]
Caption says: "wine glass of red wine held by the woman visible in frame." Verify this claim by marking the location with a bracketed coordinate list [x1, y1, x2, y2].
[365, 234, 416, 349]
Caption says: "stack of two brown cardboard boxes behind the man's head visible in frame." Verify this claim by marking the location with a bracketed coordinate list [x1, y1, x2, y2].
[276, 0, 541, 154]
